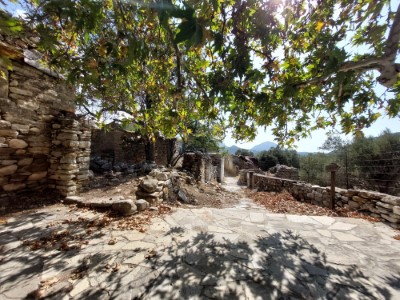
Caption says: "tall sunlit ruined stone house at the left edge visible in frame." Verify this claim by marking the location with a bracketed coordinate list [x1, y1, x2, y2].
[0, 32, 91, 210]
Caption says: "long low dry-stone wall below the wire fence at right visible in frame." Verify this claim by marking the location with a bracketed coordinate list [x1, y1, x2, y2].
[254, 174, 400, 229]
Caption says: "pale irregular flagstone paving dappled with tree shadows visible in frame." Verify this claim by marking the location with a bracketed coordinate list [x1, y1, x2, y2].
[0, 177, 400, 299]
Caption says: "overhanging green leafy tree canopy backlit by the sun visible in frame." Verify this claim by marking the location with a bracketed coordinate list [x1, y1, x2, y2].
[12, 0, 400, 144]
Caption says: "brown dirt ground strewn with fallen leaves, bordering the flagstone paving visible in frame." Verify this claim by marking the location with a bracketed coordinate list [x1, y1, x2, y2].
[0, 175, 388, 231]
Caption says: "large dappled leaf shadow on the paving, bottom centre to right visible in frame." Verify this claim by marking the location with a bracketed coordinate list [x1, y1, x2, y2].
[138, 228, 400, 299]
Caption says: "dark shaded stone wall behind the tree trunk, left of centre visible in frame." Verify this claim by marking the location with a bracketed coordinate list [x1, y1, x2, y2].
[91, 127, 171, 166]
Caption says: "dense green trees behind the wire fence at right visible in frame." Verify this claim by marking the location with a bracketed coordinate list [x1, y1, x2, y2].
[300, 130, 400, 195]
